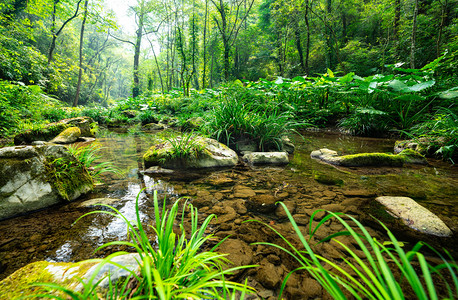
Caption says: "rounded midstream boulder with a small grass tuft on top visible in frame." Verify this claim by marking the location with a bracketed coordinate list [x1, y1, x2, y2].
[143, 136, 238, 169]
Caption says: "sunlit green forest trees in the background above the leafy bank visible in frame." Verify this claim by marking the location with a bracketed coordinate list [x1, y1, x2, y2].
[0, 0, 458, 106]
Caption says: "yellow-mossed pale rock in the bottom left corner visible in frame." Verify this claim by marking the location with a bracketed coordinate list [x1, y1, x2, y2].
[0, 253, 140, 299]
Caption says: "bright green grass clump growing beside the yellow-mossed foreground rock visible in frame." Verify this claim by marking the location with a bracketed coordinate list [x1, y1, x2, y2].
[40, 191, 253, 300]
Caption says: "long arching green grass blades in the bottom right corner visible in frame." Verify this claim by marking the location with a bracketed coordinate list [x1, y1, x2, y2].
[252, 203, 458, 299]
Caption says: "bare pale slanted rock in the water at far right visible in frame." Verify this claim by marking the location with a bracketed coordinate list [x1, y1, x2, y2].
[375, 196, 452, 237]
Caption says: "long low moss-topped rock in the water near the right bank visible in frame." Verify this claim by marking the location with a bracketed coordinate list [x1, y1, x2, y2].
[310, 148, 428, 167]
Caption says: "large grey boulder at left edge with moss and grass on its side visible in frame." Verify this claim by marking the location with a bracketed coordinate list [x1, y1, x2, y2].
[0, 145, 93, 219]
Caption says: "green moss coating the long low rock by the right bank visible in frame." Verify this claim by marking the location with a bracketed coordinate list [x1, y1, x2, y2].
[339, 153, 404, 167]
